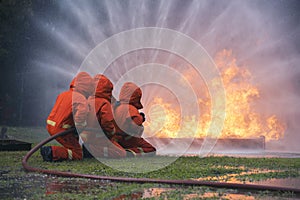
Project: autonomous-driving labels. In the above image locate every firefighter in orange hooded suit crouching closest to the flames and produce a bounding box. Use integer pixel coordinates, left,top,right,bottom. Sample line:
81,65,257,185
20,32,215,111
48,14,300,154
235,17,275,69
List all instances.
114,82,156,156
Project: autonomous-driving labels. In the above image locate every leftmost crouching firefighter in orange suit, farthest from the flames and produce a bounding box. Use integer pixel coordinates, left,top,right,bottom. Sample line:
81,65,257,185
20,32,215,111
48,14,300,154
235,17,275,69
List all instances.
41,72,94,161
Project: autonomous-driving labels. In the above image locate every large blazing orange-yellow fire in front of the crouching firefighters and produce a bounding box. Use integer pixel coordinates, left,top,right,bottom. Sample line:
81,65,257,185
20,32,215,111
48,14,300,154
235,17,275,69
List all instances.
145,50,285,141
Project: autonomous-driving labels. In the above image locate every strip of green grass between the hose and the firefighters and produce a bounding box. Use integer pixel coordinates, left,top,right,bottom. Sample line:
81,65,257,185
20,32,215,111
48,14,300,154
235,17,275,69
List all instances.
29,155,300,179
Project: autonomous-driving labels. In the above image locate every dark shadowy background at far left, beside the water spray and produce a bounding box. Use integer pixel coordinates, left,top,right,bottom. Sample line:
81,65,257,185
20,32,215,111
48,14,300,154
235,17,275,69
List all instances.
0,0,77,126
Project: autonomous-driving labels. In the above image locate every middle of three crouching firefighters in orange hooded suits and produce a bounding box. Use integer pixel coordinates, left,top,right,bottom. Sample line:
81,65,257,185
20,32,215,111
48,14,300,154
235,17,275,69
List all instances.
80,74,126,158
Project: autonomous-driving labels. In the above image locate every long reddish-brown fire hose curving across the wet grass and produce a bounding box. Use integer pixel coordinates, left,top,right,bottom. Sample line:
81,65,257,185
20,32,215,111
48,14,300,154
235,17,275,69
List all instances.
22,128,300,195
